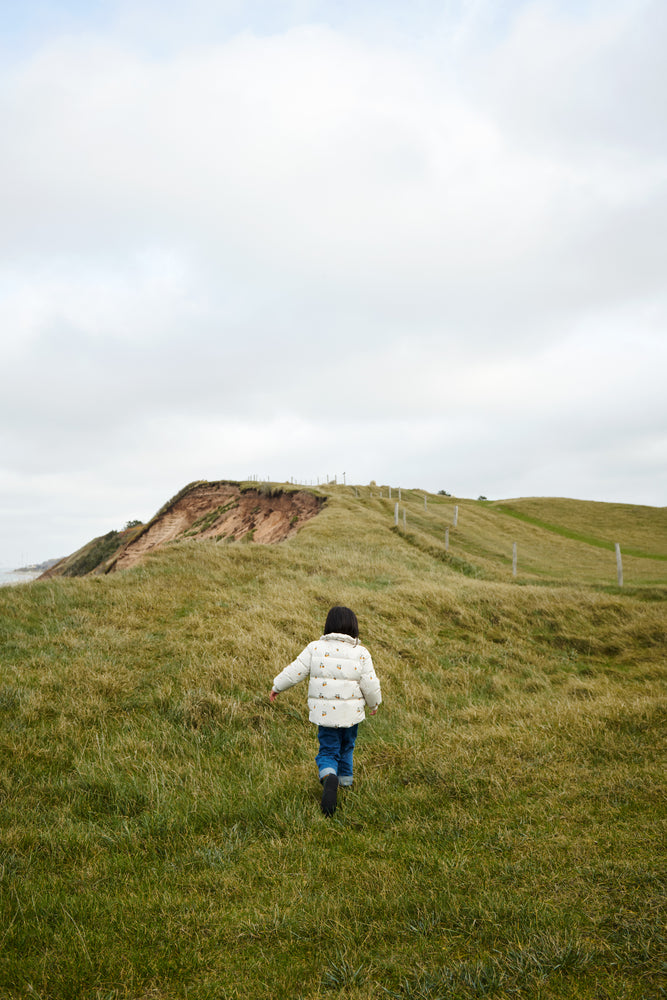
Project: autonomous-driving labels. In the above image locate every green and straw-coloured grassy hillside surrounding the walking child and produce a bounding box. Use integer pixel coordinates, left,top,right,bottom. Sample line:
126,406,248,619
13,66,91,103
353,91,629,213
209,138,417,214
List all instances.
0,487,667,1000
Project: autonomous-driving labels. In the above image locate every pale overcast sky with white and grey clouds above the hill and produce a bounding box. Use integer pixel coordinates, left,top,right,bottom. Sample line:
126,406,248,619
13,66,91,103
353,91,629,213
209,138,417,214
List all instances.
0,0,667,567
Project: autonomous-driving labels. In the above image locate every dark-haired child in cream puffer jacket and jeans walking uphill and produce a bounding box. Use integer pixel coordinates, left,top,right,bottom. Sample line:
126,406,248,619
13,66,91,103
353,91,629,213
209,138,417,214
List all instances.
269,606,382,816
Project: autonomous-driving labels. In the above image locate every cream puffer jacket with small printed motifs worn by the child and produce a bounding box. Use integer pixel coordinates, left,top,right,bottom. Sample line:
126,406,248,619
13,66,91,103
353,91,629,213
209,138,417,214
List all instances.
273,632,382,729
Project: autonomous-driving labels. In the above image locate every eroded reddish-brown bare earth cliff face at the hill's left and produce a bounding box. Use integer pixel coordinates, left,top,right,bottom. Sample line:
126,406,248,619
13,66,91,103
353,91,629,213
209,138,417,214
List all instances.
107,482,325,572
